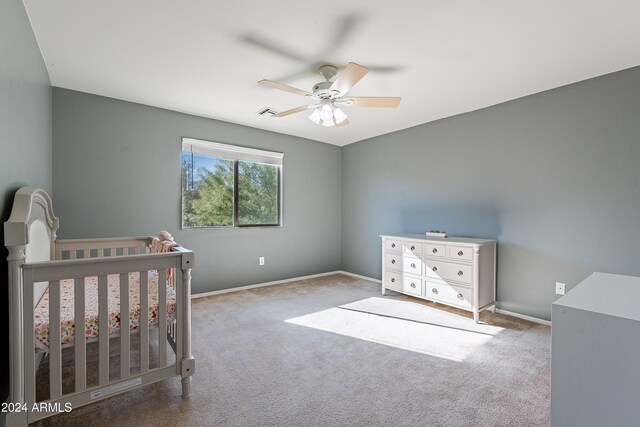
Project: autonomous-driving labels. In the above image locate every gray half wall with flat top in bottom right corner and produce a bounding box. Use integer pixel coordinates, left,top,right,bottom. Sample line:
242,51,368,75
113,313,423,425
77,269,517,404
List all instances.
550,274,640,427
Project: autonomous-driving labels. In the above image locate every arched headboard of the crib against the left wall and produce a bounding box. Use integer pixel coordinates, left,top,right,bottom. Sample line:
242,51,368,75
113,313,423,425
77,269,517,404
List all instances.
4,187,59,304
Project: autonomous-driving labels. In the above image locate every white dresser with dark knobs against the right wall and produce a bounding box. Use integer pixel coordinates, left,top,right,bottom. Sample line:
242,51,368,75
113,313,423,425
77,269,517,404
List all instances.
380,234,497,322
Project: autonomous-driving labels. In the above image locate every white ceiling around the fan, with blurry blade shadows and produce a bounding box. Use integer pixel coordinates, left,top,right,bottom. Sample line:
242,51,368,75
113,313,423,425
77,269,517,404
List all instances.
24,0,640,145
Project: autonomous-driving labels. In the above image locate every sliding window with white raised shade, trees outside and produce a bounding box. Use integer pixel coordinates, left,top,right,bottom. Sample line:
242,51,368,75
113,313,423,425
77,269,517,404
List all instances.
182,138,284,228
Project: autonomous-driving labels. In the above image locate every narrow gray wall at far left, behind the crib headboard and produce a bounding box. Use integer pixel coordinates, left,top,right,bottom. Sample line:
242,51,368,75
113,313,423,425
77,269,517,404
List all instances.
0,0,51,402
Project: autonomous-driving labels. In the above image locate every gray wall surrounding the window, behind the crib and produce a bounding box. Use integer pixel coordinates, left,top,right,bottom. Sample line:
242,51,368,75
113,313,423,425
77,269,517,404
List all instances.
53,88,341,293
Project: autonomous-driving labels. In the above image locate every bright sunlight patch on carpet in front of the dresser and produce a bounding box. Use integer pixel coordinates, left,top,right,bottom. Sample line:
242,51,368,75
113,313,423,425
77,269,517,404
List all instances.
286,297,503,362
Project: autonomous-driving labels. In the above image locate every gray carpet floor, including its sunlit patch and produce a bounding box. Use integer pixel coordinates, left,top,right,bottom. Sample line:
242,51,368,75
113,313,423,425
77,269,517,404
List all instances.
31,275,550,426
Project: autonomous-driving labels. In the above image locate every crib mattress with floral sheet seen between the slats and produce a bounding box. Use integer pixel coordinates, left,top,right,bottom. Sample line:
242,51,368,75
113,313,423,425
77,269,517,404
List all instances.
34,271,176,350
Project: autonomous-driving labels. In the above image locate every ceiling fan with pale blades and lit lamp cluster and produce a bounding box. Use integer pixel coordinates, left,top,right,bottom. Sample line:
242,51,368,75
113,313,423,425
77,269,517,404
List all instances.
258,62,401,127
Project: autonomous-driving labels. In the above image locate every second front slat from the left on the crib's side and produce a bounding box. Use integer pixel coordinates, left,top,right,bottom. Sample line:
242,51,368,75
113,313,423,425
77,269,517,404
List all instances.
49,280,62,400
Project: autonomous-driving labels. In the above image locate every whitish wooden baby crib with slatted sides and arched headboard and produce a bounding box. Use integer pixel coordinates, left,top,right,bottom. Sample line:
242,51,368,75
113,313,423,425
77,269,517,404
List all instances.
4,187,195,426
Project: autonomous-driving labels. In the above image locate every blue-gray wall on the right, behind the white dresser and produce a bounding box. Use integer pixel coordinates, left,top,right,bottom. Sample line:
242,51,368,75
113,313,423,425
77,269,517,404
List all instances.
342,67,640,319
